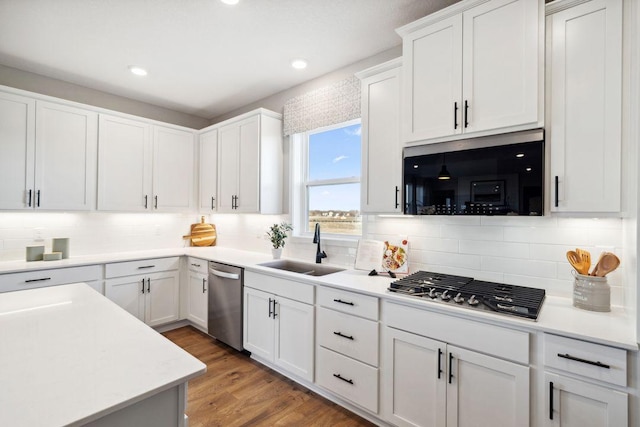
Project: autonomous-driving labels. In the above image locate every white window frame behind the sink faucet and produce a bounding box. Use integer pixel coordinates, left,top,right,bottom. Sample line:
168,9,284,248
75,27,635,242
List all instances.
289,119,362,243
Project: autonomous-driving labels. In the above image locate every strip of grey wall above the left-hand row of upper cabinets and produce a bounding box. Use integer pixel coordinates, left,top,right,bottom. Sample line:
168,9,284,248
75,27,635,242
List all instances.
0,65,209,129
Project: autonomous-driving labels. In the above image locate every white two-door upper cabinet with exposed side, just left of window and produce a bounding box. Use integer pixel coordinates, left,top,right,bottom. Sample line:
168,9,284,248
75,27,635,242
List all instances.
215,109,283,214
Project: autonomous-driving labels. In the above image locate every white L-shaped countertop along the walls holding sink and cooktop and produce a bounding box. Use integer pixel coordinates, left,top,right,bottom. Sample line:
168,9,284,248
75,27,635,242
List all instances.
0,246,638,351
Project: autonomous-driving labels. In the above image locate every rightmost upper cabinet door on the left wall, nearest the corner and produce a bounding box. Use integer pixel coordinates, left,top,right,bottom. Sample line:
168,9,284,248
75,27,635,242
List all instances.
153,126,195,212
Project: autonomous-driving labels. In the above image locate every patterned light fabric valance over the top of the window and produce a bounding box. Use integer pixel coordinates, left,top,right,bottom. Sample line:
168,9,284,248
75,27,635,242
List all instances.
283,76,360,136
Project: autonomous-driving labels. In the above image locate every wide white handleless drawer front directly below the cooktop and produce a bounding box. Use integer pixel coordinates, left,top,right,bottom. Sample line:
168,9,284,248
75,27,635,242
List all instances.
382,302,529,364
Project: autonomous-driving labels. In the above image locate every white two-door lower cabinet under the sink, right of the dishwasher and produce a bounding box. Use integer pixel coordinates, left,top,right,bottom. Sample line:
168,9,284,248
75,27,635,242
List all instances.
243,272,315,381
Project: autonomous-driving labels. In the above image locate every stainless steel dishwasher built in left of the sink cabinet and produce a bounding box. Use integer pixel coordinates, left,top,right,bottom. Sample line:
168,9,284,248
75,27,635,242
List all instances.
208,261,243,351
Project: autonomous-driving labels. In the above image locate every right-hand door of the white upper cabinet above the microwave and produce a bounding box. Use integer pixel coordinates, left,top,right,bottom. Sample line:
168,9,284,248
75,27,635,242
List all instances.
461,0,540,132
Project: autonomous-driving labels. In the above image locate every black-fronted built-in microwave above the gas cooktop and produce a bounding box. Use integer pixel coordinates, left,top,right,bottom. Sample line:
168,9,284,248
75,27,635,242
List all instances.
403,129,544,216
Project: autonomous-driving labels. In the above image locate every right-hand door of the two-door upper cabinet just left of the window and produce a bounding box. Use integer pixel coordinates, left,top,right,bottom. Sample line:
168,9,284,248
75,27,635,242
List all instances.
236,116,260,213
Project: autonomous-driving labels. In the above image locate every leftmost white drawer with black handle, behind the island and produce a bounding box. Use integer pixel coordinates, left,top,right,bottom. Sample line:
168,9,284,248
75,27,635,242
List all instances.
0,265,102,292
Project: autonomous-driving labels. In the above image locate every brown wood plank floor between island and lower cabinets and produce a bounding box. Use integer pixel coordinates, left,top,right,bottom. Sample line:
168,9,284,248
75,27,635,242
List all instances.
163,326,373,427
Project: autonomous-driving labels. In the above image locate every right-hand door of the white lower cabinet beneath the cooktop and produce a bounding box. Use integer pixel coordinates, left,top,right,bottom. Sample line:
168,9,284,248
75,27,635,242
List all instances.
447,346,529,427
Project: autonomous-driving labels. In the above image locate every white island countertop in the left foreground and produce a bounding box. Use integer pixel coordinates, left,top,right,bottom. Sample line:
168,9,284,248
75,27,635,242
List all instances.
0,284,206,427
